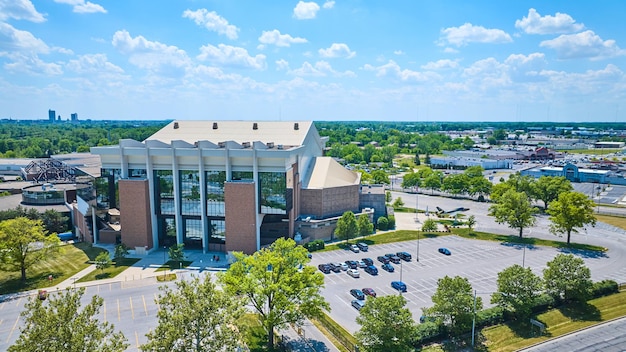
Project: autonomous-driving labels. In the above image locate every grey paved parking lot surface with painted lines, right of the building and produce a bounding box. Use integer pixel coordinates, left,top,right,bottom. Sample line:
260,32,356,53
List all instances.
312,236,605,333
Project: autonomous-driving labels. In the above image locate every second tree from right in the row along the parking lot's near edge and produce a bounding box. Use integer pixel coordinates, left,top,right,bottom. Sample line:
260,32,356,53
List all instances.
491,264,542,319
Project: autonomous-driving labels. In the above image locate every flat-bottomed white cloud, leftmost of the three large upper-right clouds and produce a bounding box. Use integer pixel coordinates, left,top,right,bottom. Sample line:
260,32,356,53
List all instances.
440,23,513,47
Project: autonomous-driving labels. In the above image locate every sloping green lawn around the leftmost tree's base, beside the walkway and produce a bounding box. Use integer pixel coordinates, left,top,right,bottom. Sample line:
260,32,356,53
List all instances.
0,243,105,294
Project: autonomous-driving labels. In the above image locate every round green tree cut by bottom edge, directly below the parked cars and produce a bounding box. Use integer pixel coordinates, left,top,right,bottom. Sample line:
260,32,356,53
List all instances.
355,295,415,352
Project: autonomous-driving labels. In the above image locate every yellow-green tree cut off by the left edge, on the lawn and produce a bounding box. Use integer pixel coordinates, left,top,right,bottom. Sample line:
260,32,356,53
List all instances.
0,217,61,282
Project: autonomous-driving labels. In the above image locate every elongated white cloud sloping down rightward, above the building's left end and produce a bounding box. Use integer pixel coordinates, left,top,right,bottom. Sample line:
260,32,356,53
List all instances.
112,30,190,70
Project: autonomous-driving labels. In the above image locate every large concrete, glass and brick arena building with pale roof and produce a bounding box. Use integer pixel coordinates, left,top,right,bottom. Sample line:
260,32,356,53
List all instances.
90,121,373,253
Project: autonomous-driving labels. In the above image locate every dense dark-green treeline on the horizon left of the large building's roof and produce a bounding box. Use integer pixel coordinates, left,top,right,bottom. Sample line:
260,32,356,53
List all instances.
0,120,167,158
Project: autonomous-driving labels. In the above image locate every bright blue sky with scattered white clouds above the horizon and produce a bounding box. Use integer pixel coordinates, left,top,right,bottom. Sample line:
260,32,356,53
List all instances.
0,0,626,122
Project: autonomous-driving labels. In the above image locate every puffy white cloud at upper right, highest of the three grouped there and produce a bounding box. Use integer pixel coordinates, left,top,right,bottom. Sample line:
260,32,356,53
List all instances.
515,8,585,34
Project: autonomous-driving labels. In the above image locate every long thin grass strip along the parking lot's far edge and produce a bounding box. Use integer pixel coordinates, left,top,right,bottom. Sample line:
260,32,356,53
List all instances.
321,228,606,252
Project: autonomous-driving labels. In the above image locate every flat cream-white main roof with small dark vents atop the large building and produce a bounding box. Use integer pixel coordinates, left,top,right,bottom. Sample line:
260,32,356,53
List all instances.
146,120,313,146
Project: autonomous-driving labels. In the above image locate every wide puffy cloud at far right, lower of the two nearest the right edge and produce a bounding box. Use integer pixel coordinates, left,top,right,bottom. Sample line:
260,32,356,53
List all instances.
539,30,626,60
